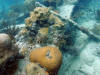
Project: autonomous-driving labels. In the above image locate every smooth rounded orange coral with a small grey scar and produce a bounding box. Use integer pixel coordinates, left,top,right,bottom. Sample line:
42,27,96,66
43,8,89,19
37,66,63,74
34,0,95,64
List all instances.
30,46,62,72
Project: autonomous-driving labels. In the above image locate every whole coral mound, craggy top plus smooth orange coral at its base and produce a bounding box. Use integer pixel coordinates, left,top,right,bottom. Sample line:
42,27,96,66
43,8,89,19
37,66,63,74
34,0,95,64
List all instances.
10,4,69,75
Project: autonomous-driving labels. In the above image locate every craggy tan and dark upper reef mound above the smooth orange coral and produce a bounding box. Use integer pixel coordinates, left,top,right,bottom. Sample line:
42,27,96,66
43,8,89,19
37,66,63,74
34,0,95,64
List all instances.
17,7,66,46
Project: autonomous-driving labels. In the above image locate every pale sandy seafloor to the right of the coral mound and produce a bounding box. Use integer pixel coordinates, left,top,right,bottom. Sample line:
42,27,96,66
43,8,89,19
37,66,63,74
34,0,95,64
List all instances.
0,0,100,75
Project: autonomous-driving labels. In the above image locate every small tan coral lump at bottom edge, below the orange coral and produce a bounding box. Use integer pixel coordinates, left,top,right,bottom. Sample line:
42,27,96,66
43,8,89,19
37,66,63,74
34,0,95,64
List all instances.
25,63,49,75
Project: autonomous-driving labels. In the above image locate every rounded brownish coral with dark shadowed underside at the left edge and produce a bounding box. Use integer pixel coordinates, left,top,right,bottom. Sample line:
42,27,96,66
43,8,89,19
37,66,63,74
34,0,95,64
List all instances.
0,33,20,75
